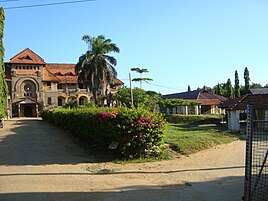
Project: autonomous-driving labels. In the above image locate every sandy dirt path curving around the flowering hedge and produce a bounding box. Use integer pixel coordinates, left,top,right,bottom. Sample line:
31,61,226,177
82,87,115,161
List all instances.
0,119,245,201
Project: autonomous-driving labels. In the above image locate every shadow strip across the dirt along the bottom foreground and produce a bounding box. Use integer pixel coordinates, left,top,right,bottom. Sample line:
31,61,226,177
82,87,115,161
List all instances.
0,177,244,201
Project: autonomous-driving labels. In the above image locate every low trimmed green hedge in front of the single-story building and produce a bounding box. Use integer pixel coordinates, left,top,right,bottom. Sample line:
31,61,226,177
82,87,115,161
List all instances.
165,114,222,123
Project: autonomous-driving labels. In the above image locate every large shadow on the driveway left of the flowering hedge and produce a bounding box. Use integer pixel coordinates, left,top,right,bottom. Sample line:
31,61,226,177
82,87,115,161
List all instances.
0,118,115,165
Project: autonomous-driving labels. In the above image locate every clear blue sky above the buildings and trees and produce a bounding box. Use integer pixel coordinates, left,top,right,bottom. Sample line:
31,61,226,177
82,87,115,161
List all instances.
0,0,268,94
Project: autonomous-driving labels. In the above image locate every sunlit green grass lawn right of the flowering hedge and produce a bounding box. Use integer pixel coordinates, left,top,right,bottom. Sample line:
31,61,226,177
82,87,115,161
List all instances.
165,124,241,154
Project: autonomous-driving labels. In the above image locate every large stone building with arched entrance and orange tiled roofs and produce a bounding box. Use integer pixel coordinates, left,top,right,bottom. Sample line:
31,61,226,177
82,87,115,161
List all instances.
5,48,123,117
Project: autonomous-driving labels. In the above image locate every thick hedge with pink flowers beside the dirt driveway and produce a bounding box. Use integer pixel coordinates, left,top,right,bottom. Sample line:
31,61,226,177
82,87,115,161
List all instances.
42,107,164,158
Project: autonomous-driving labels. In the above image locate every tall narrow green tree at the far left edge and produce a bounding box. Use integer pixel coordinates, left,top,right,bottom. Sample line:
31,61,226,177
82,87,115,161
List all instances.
0,7,8,118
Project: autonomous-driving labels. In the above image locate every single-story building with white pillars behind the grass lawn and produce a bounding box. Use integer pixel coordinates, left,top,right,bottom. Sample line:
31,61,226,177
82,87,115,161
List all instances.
162,89,227,115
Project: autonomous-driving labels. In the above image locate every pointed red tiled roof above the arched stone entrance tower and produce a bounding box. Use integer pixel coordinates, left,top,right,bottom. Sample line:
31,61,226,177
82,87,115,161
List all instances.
8,48,45,64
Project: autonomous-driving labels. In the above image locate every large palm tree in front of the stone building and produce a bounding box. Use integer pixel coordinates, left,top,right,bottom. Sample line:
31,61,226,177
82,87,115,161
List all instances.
75,35,120,104
